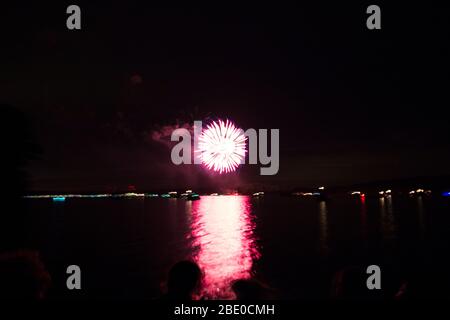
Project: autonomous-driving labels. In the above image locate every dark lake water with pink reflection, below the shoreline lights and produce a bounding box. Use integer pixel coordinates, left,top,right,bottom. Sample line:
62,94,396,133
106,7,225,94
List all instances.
27,195,450,299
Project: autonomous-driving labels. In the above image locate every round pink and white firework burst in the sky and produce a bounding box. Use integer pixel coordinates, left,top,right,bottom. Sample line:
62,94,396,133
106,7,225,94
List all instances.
197,120,246,173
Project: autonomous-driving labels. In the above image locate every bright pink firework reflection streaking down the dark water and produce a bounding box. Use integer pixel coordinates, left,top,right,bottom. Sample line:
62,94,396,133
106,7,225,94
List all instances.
190,196,260,299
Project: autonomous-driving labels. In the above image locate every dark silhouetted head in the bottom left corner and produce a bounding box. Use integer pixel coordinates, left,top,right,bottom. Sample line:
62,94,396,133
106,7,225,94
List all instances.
0,251,50,300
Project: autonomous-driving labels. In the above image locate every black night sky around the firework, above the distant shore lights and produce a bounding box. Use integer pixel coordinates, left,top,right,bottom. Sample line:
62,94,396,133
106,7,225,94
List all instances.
0,1,450,191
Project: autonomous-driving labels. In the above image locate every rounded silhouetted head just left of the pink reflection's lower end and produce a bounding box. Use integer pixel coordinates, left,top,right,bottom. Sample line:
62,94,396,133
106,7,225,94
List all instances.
163,261,202,301
